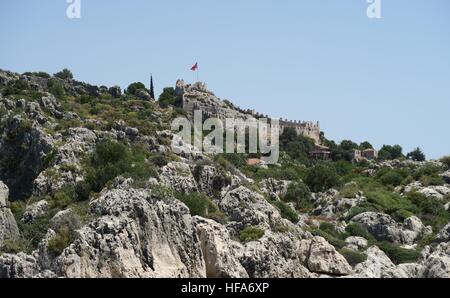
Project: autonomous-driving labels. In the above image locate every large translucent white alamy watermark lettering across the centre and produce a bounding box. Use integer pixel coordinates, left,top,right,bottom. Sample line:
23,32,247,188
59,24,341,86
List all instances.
171,110,280,164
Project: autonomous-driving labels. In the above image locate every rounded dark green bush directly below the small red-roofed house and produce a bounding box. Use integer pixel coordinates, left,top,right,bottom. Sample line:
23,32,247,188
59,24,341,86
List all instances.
304,163,340,192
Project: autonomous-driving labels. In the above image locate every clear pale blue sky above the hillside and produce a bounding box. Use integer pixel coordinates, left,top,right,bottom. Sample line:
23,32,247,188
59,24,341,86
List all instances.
0,0,450,158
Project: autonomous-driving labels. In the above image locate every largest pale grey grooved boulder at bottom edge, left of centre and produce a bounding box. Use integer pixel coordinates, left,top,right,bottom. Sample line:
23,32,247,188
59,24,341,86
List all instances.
53,189,206,277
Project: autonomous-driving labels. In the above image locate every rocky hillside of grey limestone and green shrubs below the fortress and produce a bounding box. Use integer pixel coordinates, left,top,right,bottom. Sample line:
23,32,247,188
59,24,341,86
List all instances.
0,71,450,278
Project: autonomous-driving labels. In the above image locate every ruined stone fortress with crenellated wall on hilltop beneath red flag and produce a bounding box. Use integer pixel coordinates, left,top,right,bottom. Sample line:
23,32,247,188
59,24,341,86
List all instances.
175,80,321,145
